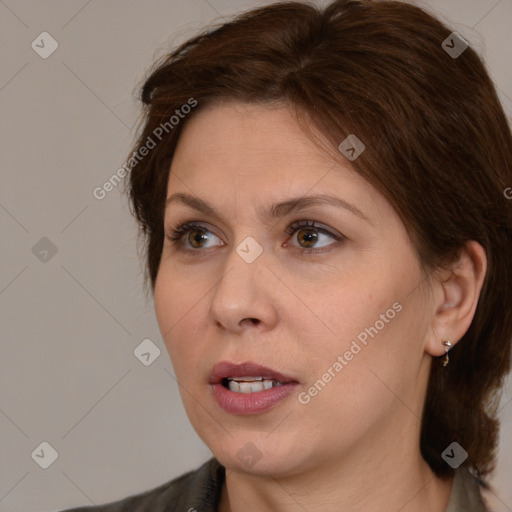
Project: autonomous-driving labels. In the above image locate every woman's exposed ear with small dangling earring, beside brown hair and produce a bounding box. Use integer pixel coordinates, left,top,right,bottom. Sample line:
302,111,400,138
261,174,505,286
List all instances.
425,240,487,356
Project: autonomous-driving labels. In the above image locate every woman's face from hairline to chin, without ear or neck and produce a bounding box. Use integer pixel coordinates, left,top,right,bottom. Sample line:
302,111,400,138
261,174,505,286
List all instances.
154,103,440,475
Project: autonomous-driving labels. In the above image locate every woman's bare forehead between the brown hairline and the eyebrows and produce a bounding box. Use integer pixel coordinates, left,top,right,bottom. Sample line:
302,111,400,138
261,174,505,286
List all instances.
167,102,385,225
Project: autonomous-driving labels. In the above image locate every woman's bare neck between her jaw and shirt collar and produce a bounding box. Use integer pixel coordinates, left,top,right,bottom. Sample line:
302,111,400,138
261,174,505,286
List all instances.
219,426,453,512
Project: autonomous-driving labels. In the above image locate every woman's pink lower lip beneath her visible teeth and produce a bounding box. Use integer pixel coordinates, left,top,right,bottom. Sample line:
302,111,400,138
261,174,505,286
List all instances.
212,382,298,414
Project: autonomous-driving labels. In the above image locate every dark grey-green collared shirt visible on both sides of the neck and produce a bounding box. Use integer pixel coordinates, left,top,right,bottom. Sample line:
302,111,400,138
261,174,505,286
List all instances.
61,458,487,512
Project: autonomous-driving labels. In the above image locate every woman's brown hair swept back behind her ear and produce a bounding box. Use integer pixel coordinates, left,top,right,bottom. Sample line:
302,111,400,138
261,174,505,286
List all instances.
124,0,512,488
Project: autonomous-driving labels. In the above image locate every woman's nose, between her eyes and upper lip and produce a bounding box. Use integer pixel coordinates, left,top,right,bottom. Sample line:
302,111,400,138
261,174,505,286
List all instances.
209,242,278,334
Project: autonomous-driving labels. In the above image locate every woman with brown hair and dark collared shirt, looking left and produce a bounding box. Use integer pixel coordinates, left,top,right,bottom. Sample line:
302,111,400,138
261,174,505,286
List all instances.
61,0,512,512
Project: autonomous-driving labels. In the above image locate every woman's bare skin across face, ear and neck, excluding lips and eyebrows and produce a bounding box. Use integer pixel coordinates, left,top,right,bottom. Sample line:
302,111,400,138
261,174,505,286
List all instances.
154,102,486,512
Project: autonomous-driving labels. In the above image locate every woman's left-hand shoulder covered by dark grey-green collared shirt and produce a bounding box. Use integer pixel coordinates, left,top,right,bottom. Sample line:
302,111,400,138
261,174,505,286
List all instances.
57,458,225,512
